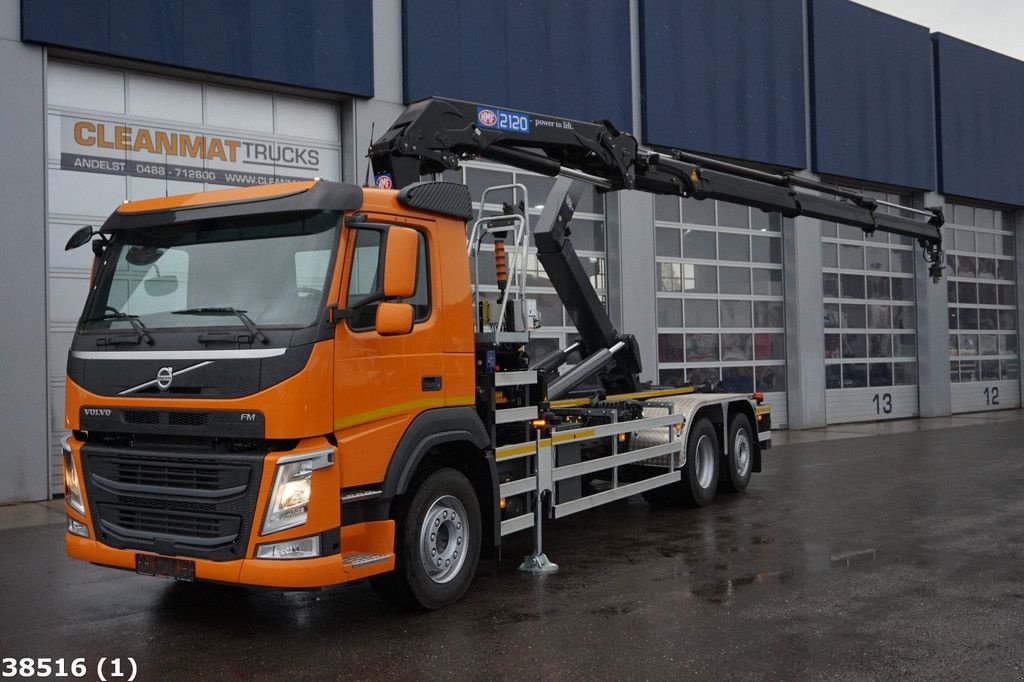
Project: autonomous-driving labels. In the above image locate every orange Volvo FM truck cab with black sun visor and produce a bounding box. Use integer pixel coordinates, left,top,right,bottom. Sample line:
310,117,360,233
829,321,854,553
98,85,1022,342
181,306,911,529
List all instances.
65,176,495,602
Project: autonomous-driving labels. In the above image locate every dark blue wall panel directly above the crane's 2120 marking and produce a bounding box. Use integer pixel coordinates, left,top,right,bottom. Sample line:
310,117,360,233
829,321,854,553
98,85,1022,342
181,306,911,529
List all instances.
402,0,633,130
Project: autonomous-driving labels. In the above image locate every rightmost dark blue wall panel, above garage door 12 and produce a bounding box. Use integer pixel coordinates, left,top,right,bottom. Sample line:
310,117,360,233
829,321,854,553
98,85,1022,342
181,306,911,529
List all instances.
932,34,1024,206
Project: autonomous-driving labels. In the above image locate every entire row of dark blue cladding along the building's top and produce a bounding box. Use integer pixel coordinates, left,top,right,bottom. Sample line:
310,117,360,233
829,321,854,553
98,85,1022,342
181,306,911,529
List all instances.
22,0,1024,205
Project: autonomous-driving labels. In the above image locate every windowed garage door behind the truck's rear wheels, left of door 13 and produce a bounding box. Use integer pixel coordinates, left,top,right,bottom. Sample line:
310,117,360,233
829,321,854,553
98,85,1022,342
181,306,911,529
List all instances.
654,196,788,427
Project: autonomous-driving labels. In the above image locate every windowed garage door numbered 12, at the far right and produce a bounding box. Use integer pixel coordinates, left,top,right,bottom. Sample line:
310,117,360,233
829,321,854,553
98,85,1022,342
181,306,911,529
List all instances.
944,204,1021,413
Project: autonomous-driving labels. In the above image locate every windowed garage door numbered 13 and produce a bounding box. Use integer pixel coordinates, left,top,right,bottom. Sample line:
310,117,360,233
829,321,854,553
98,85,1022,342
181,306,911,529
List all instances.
821,193,919,424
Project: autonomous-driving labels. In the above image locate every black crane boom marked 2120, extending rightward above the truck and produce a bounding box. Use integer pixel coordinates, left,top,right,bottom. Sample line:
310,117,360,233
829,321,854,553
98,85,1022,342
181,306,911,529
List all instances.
370,97,944,264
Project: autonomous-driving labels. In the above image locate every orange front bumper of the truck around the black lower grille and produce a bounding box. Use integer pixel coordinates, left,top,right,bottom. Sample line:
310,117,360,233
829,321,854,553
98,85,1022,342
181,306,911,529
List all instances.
65,438,394,589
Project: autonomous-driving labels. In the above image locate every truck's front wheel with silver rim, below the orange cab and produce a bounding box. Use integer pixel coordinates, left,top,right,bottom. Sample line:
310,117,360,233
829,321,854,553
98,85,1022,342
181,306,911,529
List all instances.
370,468,482,610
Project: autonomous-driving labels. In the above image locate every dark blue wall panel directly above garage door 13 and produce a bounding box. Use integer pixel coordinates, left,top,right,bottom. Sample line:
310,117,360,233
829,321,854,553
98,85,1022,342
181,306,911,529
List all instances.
809,0,936,189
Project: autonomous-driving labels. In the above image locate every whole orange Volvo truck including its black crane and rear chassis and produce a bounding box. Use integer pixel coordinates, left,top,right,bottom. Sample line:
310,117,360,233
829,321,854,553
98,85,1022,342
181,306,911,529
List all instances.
63,98,942,608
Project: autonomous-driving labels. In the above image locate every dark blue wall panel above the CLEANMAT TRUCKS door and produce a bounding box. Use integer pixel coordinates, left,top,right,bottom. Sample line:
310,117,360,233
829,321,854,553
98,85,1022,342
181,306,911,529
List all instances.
22,0,374,97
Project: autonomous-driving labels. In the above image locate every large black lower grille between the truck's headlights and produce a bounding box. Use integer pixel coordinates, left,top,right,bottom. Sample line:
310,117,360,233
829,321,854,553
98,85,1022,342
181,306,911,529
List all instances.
82,442,265,561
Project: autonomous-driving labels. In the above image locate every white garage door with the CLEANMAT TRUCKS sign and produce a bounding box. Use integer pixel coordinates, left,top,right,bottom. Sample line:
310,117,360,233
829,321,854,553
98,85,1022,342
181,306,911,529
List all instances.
47,61,341,494
